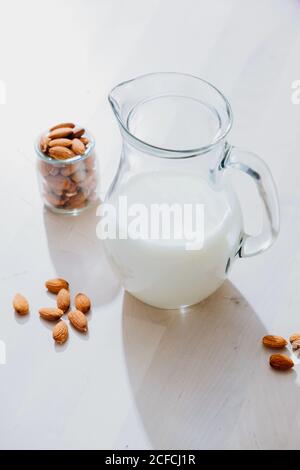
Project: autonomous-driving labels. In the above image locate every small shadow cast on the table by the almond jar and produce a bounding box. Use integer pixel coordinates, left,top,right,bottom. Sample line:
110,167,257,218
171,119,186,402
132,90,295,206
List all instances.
44,207,120,306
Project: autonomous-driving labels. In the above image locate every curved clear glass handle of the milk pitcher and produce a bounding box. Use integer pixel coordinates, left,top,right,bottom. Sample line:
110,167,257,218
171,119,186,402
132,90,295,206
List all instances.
223,146,279,258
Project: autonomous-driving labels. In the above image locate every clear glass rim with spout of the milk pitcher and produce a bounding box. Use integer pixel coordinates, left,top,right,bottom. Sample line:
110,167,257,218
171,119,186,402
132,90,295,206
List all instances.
108,72,233,159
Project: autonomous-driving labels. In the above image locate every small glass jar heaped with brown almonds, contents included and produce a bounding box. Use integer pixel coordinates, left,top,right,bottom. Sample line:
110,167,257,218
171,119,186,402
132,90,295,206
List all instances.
35,123,98,215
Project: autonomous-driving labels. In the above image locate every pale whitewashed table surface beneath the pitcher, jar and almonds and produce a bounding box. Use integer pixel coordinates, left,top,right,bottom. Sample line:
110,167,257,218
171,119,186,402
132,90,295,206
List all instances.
0,0,300,449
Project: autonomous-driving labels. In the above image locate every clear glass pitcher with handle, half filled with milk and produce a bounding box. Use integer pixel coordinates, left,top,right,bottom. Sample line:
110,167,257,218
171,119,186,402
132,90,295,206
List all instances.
102,73,279,309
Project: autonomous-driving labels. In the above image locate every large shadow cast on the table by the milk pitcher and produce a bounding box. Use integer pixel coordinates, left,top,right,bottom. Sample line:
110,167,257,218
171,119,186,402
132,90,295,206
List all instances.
122,281,298,449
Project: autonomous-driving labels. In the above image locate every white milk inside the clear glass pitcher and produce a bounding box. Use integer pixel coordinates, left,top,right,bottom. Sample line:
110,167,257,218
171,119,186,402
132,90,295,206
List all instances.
105,172,242,308
